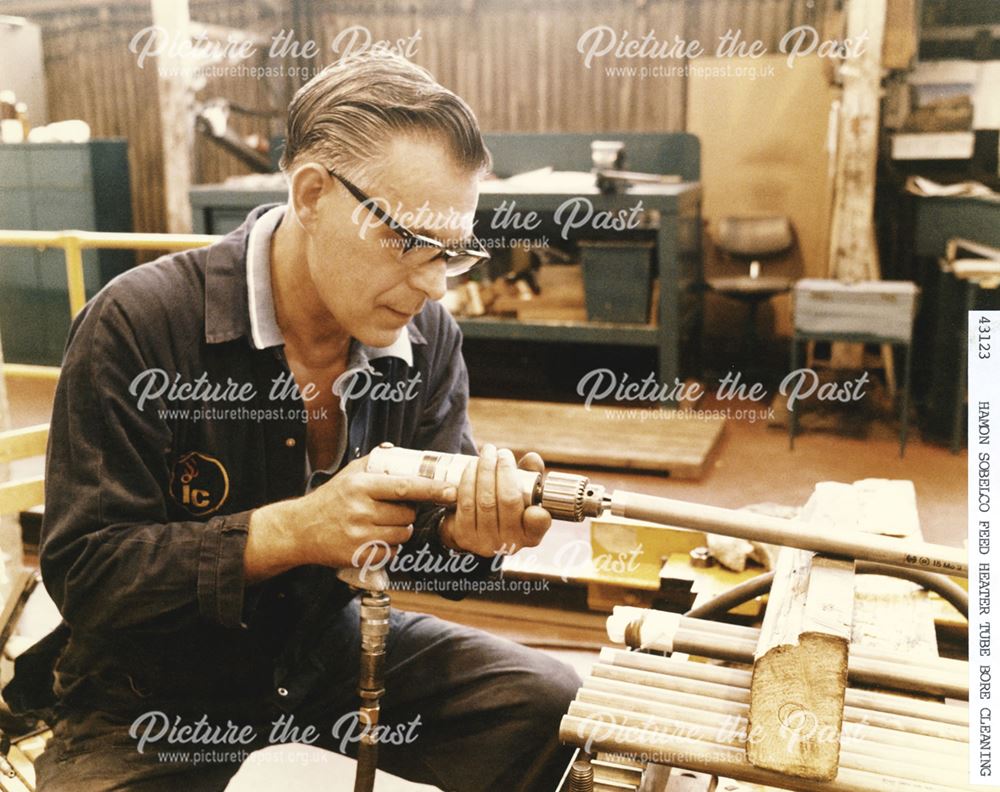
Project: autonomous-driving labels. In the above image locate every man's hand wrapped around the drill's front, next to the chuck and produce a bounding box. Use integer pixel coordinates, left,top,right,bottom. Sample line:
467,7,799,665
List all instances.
441,444,552,558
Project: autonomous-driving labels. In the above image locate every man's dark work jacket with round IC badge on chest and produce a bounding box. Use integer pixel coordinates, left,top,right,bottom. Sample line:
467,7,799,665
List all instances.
31,207,489,717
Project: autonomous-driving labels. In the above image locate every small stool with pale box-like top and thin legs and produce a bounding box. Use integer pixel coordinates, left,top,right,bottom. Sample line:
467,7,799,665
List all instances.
788,278,919,457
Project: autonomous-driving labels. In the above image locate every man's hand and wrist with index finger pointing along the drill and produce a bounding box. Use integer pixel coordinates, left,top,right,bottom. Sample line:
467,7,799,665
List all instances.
244,457,457,583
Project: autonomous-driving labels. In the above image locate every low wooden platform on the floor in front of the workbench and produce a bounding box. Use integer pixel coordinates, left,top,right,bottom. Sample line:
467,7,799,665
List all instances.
469,399,725,479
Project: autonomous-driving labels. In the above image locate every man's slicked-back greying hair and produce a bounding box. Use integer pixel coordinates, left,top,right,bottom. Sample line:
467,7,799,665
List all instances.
280,54,490,184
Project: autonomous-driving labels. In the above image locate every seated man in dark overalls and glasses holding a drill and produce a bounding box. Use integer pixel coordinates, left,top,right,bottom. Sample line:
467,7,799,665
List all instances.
12,56,579,792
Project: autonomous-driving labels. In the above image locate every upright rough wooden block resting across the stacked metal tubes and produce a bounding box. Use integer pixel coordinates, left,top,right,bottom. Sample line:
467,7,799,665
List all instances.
746,548,854,781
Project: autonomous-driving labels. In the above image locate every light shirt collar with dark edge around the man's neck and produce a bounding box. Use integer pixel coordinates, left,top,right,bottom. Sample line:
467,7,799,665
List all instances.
219,204,418,368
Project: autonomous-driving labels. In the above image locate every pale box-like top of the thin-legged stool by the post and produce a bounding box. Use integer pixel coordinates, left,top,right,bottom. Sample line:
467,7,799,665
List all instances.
793,278,920,342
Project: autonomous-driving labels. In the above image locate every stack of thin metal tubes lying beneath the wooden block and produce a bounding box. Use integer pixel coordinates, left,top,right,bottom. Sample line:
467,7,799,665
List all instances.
560,648,972,792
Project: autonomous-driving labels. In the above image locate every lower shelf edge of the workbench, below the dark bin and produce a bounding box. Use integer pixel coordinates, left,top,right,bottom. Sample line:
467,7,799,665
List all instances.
458,318,660,347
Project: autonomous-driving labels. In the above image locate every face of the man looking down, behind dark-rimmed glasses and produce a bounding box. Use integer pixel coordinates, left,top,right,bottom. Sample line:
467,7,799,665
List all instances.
307,137,479,347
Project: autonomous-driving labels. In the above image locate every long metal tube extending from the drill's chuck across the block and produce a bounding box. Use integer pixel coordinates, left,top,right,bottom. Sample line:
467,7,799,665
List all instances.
610,490,969,577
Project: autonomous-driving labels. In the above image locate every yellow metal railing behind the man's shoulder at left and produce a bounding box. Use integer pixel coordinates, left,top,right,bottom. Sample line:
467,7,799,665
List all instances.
0,230,221,379
